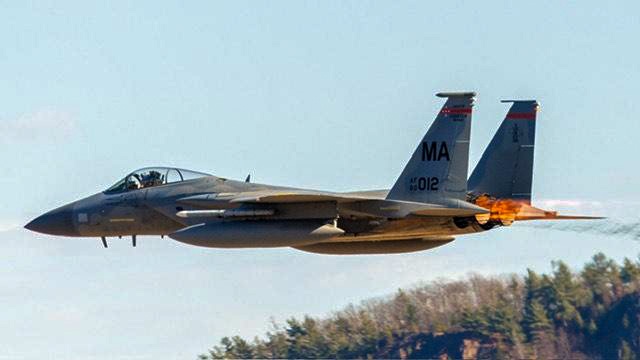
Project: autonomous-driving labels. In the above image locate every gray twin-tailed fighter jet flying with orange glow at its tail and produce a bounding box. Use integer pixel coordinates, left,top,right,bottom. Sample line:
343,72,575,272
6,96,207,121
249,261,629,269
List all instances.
25,92,596,254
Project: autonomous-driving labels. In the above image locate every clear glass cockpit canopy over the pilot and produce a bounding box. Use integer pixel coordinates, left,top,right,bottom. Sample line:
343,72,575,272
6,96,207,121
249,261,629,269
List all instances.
105,167,211,194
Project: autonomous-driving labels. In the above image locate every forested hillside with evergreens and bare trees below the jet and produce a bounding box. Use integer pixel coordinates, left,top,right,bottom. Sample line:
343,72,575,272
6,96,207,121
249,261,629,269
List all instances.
200,254,640,359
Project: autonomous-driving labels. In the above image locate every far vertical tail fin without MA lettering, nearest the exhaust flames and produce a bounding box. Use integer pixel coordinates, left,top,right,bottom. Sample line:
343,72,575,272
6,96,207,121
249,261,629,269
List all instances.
469,100,538,203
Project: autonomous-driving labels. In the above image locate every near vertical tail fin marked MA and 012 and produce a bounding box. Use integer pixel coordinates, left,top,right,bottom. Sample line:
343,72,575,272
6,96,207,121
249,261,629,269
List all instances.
387,92,475,204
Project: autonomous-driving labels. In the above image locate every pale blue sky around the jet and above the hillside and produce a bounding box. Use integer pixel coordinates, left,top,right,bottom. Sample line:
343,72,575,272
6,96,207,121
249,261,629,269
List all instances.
0,1,640,359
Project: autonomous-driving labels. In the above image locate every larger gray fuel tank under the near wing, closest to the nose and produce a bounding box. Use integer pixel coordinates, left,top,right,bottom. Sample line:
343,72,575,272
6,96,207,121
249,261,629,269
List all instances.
169,220,344,248
